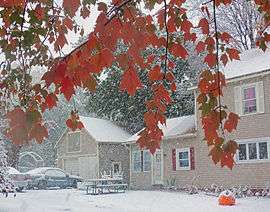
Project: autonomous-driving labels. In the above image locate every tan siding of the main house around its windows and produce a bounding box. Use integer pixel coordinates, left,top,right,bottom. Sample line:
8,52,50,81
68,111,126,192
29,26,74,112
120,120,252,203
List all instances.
130,72,270,189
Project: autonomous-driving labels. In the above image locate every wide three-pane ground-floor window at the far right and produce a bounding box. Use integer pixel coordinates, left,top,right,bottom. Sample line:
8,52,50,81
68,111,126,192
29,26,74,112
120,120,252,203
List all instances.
237,139,270,162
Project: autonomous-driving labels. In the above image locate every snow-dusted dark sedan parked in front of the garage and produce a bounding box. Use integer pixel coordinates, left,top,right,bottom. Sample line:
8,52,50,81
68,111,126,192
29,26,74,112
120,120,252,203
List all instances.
27,167,83,189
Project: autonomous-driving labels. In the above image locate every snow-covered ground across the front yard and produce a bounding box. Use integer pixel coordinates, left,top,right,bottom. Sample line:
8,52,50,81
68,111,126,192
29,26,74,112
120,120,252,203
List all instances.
0,190,270,212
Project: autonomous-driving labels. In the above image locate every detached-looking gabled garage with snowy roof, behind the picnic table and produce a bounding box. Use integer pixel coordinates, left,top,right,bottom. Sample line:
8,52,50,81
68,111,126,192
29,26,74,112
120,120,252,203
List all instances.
56,116,130,182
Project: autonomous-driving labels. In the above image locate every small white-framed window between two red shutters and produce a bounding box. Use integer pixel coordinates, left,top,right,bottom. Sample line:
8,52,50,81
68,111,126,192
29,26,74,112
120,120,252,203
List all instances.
176,148,190,170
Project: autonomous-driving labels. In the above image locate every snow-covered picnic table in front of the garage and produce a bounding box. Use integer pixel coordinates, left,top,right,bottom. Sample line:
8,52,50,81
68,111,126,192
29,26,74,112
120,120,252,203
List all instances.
85,178,128,195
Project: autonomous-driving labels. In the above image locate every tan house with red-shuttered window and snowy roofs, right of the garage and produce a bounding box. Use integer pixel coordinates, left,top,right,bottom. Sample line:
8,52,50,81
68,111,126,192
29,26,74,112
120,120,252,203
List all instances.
127,49,270,189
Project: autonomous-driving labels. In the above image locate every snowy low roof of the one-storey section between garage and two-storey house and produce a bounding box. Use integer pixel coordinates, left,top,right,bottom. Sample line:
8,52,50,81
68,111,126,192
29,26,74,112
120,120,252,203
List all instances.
127,115,196,142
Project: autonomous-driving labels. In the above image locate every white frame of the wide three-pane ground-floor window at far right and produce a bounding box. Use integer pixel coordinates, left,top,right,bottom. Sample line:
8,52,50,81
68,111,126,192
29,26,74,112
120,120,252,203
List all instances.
235,137,270,164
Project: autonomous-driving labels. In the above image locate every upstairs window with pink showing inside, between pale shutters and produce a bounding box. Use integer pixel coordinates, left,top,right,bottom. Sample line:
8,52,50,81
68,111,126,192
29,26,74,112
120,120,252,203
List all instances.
242,86,257,114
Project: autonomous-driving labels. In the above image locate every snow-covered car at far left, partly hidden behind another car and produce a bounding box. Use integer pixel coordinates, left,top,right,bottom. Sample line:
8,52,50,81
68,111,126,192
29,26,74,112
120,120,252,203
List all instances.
7,167,30,191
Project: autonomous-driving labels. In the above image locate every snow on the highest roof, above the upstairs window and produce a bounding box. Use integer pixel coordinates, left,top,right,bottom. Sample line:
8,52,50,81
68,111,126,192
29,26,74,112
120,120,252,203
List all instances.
223,48,270,79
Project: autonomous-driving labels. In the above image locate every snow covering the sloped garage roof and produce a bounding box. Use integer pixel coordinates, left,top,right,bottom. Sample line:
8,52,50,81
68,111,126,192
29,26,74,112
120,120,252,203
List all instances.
80,116,131,143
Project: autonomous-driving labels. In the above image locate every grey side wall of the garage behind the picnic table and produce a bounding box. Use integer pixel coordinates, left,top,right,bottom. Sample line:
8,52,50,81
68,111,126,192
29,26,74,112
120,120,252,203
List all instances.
98,143,129,183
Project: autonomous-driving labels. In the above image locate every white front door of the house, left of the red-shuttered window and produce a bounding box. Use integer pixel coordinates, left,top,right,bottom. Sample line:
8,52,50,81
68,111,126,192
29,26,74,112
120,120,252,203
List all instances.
152,150,163,185
